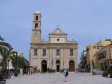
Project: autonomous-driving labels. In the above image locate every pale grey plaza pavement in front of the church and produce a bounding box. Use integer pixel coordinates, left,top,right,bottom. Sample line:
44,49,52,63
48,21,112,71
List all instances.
6,72,112,84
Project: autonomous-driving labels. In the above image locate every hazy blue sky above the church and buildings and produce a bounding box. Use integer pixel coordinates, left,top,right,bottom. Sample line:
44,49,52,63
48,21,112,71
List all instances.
0,0,112,61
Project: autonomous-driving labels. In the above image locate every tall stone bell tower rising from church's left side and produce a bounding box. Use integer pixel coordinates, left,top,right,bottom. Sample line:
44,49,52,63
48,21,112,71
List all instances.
31,11,41,43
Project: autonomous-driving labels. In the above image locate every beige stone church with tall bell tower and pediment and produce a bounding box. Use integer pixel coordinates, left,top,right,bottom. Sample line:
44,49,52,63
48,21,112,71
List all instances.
29,11,78,72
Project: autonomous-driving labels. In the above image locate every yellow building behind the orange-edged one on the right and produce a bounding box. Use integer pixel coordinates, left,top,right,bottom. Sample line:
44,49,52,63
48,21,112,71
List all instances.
86,40,111,72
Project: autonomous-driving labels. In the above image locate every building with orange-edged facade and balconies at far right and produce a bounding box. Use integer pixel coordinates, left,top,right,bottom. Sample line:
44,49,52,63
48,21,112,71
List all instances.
97,44,112,70
